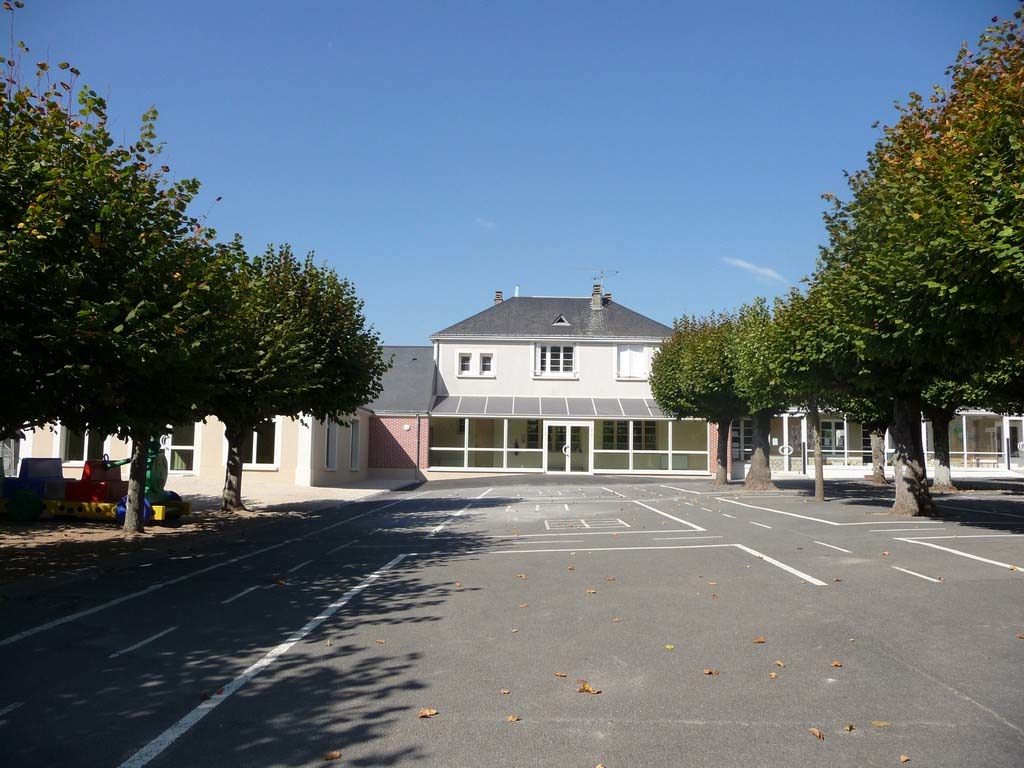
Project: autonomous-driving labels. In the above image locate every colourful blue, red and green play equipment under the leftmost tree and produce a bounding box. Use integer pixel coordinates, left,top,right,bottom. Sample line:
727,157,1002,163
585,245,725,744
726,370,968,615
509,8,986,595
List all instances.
0,440,191,523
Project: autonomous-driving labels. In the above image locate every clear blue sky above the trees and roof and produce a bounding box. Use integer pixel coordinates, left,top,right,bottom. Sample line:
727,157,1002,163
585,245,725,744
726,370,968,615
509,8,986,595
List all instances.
15,0,1016,344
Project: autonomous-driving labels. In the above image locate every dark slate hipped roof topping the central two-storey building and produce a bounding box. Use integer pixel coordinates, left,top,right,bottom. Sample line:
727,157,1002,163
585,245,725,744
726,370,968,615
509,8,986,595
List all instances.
430,296,672,340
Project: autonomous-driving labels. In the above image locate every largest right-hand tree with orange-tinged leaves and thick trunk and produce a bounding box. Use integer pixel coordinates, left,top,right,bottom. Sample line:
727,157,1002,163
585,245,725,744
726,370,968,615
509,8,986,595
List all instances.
815,9,1024,514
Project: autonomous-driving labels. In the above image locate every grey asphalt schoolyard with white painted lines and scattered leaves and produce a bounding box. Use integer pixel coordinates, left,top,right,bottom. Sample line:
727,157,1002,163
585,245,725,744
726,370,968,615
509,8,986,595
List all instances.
0,476,1024,768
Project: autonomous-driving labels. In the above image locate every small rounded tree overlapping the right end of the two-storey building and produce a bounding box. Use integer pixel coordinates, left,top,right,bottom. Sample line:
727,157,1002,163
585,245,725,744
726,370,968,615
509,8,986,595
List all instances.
650,312,746,484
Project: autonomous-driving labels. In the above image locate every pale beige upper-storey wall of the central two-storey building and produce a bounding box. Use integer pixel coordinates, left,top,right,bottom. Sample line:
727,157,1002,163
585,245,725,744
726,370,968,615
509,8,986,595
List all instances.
437,340,652,397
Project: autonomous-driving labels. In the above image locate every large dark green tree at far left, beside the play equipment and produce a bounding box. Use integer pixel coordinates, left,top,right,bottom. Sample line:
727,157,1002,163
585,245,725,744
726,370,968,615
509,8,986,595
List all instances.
0,20,232,532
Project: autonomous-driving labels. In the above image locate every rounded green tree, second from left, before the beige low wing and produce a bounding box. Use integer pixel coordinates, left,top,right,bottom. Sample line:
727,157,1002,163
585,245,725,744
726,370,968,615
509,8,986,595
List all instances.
203,246,387,510
